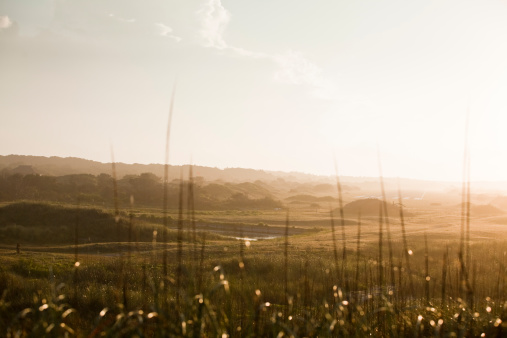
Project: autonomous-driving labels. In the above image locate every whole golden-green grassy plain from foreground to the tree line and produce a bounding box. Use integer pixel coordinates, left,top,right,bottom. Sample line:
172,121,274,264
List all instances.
0,195,507,336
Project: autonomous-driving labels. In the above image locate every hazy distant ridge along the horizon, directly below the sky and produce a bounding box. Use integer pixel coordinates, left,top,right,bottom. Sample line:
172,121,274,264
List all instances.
0,155,507,197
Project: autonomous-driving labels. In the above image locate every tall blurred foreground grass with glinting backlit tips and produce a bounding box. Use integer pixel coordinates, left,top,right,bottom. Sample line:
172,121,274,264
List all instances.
1,198,505,336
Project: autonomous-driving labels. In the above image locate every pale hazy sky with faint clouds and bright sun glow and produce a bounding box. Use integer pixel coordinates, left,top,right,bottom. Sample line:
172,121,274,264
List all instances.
0,0,507,181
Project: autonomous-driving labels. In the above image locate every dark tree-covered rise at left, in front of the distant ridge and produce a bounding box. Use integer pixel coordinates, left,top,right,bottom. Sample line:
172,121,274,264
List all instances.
0,173,282,209
